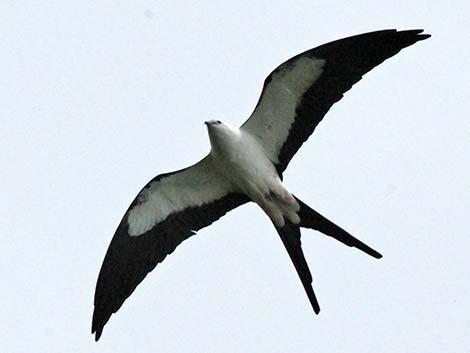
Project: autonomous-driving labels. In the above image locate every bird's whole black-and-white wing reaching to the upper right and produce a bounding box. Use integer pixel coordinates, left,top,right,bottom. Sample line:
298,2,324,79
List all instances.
242,30,430,174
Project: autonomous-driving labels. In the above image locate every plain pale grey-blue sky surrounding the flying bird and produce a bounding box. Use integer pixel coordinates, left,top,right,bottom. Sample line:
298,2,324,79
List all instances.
0,0,470,353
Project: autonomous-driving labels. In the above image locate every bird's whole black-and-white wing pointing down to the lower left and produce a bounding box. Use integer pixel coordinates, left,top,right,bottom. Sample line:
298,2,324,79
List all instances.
92,156,249,340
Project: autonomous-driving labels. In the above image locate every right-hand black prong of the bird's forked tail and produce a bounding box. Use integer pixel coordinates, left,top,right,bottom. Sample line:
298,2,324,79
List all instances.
295,198,382,259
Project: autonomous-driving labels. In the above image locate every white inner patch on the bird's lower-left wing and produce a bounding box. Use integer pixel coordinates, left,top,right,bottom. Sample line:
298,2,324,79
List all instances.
127,157,231,236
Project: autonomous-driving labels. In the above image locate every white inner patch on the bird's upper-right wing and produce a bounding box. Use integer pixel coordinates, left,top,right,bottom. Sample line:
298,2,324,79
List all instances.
242,56,325,163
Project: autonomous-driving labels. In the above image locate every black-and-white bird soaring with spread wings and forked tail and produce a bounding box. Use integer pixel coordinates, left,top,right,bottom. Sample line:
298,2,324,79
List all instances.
92,30,430,340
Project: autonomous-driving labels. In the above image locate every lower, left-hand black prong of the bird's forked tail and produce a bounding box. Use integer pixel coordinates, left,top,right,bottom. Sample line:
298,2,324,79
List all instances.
276,220,320,314
